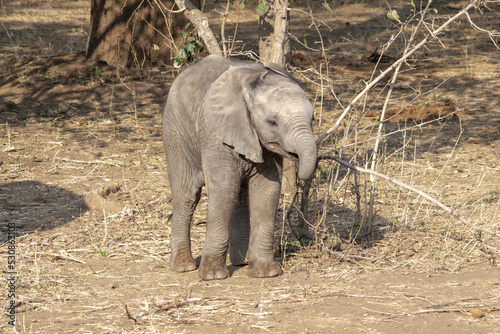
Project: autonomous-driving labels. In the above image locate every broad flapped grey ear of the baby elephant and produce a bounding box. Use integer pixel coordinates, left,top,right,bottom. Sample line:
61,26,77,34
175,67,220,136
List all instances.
202,64,267,163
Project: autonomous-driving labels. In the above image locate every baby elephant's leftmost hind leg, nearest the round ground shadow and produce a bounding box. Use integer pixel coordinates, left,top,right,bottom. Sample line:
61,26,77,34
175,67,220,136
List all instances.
170,172,202,272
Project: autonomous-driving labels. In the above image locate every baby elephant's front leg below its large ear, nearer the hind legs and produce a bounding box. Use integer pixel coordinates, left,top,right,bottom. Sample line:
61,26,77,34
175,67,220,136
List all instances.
198,167,241,280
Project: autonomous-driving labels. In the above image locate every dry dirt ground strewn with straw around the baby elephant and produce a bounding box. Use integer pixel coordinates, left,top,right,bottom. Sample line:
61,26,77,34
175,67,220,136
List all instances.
0,0,500,334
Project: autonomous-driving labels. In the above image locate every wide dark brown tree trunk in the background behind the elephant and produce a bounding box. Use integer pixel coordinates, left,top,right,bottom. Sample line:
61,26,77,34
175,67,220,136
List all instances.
86,0,200,67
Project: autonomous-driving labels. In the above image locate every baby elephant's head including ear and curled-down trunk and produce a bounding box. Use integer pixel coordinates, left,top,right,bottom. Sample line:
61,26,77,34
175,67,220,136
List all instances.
203,63,316,180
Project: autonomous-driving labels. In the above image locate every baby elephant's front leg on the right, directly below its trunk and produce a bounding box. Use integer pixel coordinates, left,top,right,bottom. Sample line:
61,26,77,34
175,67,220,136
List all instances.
247,159,283,277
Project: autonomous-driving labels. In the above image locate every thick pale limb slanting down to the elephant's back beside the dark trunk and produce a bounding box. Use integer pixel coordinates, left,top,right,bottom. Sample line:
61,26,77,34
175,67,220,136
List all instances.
175,0,222,56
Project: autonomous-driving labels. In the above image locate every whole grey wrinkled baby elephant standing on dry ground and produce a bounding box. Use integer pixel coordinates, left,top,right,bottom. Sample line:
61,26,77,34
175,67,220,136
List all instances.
163,55,316,280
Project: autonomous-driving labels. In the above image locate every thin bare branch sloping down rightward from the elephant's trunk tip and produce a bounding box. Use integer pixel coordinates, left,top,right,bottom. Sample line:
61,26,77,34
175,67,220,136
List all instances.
318,155,497,236
